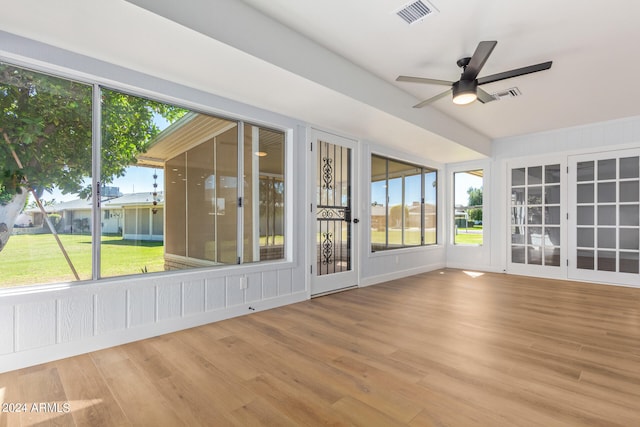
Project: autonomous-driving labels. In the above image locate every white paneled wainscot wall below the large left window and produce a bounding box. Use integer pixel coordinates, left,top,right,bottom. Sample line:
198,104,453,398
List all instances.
0,263,308,372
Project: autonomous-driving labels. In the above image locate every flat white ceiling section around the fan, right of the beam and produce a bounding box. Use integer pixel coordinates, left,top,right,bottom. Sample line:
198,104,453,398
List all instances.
243,0,640,138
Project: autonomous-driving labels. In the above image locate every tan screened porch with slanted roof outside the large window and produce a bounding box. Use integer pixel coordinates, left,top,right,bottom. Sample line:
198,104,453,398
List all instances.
140,112,285,269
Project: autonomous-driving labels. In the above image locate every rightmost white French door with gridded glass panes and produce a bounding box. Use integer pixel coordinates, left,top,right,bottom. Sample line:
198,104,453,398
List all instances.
569,149,640,286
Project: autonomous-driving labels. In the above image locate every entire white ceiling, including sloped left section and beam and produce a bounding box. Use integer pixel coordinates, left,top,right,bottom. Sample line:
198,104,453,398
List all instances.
0,0,640,163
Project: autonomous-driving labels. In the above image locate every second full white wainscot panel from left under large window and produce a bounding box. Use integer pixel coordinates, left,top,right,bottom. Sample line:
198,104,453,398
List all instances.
58,293,94,342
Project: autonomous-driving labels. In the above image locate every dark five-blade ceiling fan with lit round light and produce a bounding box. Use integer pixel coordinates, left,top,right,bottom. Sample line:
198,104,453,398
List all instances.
396,41,552,108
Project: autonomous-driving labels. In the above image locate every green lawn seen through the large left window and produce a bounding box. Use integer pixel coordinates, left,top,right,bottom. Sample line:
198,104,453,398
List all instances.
0,234,164,287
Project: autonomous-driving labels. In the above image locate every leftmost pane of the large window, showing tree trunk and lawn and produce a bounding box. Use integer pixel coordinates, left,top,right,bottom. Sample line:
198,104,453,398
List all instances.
0,63,93,287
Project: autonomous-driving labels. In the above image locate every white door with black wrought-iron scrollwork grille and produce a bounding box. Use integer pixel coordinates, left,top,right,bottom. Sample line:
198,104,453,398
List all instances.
311,130,359,296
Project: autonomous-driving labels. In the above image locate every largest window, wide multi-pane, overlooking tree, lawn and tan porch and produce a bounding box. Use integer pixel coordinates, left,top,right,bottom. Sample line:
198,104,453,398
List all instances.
0,64,285,287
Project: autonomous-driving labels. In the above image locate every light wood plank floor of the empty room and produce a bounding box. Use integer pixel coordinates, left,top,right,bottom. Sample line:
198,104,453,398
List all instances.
0,270,640,427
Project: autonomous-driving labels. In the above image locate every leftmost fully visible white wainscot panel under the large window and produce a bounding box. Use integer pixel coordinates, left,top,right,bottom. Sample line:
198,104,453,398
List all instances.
16,300,56,351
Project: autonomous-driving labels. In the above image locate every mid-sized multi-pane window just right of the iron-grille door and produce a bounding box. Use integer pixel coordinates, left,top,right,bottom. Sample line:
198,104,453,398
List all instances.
371,155,437,252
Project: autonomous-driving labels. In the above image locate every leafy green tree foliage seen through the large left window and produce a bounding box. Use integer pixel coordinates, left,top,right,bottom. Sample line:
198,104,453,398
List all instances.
0,63,186,251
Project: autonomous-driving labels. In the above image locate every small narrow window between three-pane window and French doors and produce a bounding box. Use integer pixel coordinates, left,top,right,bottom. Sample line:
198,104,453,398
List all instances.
453,169,484,245
